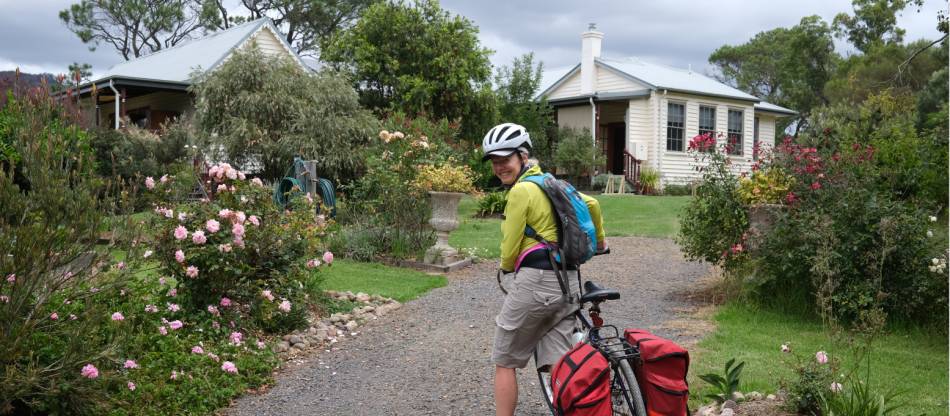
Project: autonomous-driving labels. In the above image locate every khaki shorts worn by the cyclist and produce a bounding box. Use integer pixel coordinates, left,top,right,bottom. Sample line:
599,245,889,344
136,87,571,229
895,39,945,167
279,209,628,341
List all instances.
492,267,577,368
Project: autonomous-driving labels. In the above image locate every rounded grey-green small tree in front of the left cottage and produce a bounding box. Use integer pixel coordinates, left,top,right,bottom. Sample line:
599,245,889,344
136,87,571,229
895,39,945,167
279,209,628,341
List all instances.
191,45,378,181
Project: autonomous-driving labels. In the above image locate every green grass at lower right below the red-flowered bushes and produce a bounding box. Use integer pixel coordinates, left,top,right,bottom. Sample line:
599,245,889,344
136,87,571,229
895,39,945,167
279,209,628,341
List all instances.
690,304,948,415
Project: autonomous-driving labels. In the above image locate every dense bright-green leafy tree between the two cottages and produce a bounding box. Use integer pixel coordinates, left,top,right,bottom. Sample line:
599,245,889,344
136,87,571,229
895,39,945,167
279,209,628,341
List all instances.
322,0,494,140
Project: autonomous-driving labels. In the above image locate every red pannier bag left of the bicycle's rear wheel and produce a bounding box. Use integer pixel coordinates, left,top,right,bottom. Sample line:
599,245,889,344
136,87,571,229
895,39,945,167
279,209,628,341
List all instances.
551,342,613,416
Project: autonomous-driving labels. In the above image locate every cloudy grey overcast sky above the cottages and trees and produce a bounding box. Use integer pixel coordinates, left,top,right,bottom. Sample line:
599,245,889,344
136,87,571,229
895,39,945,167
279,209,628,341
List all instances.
0,0,947,79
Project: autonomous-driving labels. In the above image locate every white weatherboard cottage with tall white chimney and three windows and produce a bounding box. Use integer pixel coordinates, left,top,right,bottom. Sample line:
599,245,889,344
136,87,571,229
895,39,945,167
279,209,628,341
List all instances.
537,25,797,186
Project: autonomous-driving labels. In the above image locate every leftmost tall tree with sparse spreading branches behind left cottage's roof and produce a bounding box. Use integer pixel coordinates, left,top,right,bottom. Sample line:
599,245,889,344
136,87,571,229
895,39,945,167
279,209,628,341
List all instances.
59,0,214,60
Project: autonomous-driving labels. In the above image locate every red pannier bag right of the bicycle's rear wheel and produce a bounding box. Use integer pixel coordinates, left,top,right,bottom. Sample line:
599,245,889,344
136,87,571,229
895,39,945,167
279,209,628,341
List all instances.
623,329,689,416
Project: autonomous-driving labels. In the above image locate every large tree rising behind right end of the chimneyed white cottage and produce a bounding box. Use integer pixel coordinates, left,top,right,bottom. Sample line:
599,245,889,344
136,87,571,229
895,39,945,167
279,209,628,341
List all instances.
709,16,840,135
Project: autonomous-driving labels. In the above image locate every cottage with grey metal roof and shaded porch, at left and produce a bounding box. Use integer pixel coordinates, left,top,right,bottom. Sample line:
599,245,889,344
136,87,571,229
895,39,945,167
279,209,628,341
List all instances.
79,17,310,130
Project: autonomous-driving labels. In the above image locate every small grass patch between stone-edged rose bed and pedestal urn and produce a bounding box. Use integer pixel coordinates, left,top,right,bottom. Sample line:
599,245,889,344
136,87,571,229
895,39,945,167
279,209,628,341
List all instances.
320,259,448,302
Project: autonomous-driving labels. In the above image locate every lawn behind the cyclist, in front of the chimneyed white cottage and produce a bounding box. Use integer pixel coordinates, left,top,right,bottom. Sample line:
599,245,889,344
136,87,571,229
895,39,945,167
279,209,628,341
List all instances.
449,195,690,258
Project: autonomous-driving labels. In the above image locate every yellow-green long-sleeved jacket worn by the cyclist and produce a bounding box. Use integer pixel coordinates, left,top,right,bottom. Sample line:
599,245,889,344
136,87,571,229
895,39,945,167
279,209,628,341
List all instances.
501,165,604,271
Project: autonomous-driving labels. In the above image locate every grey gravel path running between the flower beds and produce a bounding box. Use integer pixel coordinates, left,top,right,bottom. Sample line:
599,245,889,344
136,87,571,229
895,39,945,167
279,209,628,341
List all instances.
225,237,709,416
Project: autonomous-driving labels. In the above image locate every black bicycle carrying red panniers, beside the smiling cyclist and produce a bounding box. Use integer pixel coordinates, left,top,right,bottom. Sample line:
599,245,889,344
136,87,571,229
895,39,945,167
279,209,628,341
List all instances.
535,249,646,416
